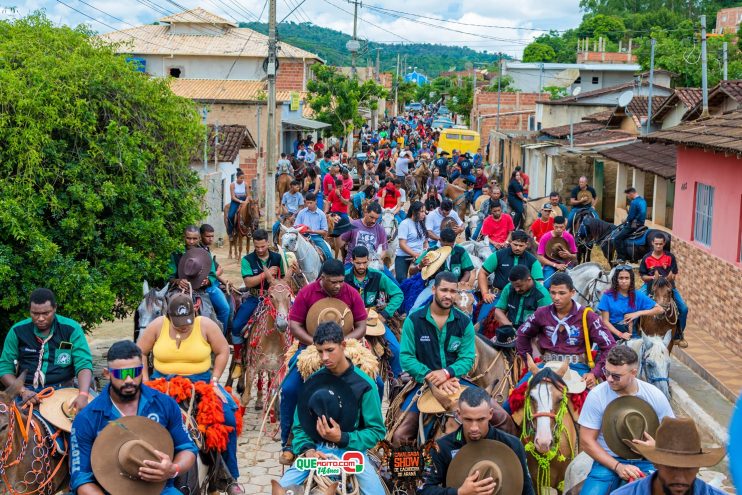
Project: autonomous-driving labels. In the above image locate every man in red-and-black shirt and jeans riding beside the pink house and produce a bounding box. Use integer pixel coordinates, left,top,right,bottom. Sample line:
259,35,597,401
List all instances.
639,235,688,348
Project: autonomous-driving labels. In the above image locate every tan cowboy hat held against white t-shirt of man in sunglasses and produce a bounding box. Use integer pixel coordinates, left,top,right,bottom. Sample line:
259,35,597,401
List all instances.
601,395,660,459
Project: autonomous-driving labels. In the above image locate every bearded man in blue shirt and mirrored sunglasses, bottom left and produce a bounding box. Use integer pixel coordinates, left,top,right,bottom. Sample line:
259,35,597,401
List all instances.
70,340,198,495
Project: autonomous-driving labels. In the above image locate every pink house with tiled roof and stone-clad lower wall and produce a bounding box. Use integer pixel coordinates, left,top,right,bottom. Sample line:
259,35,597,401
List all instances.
642,110,742,349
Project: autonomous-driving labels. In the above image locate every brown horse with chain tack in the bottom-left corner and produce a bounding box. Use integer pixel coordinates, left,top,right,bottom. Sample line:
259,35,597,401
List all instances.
0,372,70,495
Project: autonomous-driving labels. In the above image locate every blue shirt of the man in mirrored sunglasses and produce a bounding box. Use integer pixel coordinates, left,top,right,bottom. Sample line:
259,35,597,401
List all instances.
70,385,198,492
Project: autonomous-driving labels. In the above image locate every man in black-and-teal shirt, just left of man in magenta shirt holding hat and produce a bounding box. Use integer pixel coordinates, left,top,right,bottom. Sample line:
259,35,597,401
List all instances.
477,230,544,322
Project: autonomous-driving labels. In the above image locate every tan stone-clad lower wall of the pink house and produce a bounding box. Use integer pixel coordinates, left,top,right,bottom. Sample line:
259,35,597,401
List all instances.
672,236,742,348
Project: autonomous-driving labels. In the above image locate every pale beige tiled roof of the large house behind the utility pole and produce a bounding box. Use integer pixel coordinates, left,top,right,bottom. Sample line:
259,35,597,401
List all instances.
99,25,321,60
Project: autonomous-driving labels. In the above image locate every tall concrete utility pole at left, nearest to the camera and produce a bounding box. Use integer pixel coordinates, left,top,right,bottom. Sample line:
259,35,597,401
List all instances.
265,0,278,230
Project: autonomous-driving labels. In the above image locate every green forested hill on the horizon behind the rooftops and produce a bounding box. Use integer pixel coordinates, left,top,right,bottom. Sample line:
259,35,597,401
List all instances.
240,22,507,79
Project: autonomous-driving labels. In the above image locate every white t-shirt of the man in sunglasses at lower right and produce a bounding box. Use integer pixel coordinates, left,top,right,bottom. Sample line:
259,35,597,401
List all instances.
578,380,675,457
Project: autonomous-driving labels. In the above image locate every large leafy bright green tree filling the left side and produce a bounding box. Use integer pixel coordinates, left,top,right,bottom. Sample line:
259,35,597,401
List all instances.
0,13,204,336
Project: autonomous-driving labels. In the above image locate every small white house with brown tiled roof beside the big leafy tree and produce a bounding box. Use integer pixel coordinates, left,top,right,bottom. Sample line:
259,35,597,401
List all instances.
191,125,257,236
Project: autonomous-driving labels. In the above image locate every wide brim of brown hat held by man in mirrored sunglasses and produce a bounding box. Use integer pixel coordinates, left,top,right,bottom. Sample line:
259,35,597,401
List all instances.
90,416,175,495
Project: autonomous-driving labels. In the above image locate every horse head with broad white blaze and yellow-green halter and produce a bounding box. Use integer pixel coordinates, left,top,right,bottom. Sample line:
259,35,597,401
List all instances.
525,354,569,454
